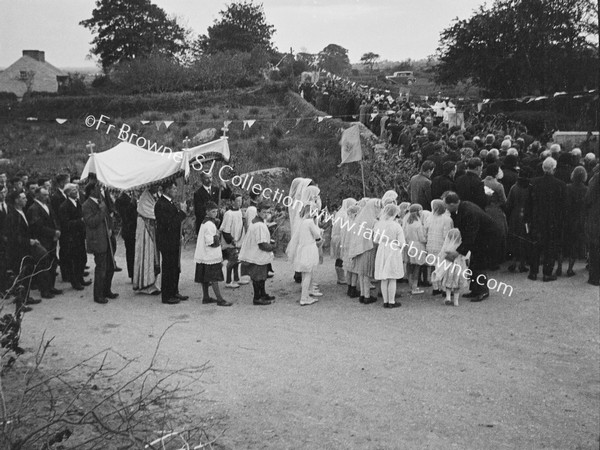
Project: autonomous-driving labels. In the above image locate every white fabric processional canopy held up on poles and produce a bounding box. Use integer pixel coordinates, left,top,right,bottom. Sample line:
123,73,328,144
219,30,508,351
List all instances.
81,138,230,190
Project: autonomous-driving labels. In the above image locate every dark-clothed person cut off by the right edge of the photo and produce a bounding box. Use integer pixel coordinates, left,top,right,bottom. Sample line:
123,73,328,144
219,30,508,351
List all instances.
584,166,600,286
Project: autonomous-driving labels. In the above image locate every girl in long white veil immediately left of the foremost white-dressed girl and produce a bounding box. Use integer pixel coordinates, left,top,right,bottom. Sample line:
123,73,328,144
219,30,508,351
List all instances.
348,198,381,304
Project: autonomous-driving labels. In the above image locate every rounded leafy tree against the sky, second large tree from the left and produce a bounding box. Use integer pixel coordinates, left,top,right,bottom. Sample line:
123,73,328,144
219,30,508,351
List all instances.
197,1,275,54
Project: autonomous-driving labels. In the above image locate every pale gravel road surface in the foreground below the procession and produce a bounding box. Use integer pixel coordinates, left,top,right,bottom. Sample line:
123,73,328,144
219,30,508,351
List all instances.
23,246,600,449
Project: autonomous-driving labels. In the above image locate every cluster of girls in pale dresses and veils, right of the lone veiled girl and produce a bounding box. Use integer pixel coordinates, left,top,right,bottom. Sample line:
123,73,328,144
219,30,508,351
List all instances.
331,191,468,308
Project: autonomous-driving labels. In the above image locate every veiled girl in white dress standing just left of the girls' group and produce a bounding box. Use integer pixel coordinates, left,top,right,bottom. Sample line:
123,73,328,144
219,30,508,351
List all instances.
287,203,322,306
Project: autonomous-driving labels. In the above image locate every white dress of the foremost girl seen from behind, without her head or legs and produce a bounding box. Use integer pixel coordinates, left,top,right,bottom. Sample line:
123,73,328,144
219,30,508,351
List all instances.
374,220,405,280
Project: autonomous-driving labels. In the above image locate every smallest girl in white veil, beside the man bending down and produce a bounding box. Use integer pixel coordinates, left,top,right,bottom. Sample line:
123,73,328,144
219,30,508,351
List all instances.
432,228,470,306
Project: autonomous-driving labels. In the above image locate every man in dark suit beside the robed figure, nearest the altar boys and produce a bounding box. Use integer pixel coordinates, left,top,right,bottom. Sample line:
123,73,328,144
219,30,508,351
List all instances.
154,181,189,305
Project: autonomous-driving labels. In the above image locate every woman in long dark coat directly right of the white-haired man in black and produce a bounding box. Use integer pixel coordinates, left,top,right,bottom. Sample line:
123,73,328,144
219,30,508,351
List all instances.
563,166,588,277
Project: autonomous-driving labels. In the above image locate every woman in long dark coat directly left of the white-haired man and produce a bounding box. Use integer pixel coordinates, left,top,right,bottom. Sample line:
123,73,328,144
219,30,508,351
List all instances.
506,166,532,272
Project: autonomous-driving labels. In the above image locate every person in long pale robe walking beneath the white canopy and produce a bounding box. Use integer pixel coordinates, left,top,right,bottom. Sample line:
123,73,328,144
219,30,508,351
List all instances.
133,186,160,295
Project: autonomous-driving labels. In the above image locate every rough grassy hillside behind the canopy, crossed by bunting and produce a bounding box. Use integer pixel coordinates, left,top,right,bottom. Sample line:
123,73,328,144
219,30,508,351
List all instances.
0,85,418,205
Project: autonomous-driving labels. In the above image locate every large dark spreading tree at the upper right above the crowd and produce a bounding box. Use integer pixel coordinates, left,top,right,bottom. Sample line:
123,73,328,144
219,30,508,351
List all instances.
435,0,598,97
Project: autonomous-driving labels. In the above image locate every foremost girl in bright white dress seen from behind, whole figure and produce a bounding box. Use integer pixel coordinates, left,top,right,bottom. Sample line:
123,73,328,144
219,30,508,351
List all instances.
374,204,405,308
